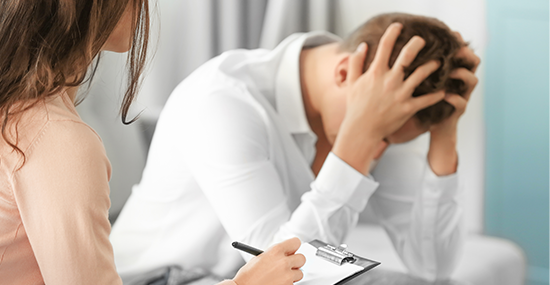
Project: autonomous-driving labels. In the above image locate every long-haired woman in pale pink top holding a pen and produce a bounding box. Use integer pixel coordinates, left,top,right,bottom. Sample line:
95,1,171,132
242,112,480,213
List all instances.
0,0,305,285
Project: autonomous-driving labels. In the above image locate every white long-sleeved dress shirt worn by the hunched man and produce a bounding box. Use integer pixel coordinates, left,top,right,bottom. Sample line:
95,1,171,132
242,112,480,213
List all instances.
111,32,461,279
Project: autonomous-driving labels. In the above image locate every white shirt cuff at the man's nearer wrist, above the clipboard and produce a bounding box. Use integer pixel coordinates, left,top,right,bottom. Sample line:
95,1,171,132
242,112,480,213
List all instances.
313,152,378,212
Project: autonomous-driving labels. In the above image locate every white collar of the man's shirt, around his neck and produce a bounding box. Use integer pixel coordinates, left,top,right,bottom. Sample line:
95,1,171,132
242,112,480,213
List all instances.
275,32,341,134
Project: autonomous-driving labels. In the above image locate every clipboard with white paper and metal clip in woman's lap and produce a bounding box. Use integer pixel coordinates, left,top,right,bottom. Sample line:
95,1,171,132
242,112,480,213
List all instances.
295,240,380,285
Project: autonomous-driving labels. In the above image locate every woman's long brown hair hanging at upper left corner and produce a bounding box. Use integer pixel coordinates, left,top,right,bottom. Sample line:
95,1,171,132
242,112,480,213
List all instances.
0,0,149,162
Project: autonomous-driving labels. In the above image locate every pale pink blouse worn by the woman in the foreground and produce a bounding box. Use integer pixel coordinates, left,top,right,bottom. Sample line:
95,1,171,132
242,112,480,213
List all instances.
0,94,122,285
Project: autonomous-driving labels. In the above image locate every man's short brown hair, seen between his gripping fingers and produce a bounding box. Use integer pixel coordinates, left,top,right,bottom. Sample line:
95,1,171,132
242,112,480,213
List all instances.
341,13,473,125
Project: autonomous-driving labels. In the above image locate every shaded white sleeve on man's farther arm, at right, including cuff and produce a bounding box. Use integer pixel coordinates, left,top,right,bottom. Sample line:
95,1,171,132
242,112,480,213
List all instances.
367,141,463,280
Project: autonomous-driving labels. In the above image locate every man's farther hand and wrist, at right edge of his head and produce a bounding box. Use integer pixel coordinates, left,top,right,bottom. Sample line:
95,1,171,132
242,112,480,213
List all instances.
428,33,481,176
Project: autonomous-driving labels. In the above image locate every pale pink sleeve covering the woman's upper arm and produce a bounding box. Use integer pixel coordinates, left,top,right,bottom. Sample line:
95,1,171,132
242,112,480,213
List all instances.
13,121,122,284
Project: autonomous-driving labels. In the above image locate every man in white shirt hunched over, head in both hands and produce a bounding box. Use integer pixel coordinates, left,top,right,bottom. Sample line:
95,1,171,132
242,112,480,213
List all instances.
111,14,479,280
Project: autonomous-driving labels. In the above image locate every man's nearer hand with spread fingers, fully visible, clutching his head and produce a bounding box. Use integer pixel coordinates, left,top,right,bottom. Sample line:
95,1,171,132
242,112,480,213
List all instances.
332,23,445,174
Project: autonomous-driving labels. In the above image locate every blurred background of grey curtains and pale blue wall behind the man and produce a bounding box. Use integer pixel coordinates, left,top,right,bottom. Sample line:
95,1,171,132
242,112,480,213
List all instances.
78,0,549,285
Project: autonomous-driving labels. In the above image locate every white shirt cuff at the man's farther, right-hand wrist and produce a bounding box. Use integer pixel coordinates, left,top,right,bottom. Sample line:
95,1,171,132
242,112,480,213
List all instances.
423,160,459,204
